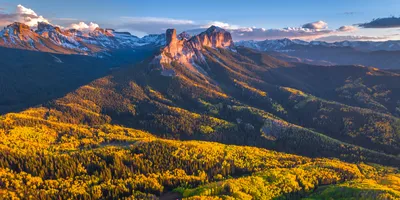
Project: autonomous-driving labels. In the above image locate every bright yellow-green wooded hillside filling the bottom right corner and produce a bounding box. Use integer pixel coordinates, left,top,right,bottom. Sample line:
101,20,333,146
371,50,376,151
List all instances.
180,161,400,200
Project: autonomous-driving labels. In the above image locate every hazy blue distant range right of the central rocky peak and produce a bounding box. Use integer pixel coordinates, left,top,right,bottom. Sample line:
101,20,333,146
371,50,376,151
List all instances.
236,39,400,69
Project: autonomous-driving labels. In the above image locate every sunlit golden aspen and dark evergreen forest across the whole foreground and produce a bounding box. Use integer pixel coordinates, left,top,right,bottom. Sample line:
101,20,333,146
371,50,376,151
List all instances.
0,108,400,199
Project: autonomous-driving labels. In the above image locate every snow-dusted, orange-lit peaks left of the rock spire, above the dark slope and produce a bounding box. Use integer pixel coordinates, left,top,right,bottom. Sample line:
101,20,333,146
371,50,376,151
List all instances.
0,22,165,56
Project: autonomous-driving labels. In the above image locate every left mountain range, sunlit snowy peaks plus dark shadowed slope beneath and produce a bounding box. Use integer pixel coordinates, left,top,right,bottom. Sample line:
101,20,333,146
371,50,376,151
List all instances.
0,22,165,114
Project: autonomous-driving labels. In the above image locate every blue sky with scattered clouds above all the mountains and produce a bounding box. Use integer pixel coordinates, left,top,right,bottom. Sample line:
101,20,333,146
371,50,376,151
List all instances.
0,0,400,42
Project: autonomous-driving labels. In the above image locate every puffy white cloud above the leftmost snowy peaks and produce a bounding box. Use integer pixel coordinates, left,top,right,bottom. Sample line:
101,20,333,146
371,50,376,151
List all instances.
0,5,50,27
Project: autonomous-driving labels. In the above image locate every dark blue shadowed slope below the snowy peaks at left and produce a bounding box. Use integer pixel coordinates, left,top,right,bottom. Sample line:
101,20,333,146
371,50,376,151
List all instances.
0,47,155,114
